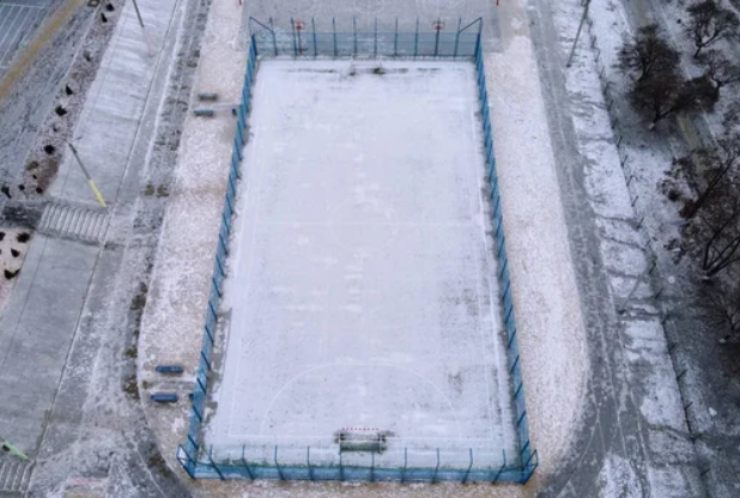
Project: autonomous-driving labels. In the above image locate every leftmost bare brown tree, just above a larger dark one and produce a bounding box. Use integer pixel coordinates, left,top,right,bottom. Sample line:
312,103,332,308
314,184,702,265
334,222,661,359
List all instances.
617,24,681,81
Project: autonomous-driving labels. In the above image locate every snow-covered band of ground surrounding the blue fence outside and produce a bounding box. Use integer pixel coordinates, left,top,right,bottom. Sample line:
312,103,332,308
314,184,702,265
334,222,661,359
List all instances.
139,0,593,497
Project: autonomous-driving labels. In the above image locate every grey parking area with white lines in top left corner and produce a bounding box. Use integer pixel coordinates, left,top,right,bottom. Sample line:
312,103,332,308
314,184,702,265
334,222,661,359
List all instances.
0,0,54,75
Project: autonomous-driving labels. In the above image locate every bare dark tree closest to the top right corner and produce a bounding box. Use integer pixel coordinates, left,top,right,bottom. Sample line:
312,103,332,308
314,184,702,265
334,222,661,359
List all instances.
686,0,740,57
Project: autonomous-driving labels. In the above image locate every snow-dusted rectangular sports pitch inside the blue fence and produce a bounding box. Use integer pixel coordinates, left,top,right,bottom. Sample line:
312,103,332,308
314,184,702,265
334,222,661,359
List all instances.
205,61,516,464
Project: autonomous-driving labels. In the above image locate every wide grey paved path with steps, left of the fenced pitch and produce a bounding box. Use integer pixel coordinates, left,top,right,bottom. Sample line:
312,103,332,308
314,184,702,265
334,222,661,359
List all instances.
0,0,205,496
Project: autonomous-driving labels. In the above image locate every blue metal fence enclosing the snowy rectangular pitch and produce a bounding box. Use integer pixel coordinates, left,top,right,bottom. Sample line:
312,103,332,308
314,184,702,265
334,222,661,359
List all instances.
177,20,538,483
